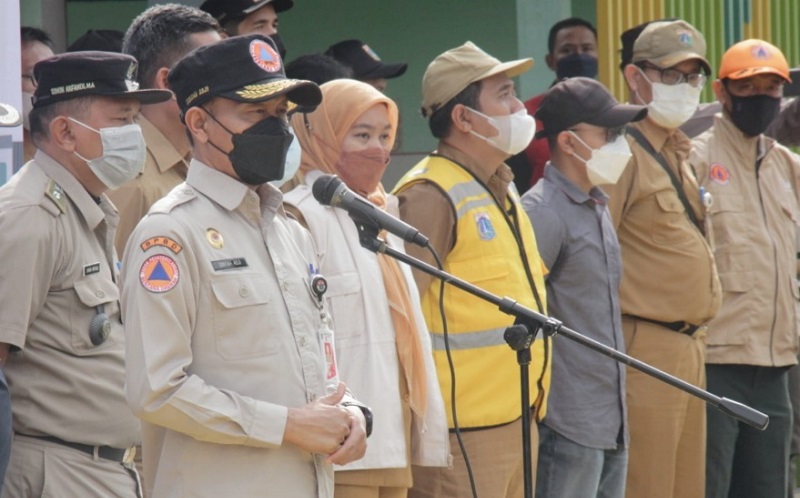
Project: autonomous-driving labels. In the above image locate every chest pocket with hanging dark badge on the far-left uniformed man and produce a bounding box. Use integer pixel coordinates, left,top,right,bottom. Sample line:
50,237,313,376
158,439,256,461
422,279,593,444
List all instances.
69,273,120,355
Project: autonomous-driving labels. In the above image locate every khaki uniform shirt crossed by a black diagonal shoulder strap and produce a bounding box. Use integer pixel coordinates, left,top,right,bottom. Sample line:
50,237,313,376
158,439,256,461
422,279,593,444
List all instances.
603,119,721,325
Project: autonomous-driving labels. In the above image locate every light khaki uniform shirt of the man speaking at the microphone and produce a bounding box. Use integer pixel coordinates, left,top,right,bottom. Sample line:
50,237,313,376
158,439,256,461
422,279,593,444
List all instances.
121,160,333,498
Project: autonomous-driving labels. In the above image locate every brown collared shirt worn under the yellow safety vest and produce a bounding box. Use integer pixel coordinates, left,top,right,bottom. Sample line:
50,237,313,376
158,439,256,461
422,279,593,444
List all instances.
397,143,514,292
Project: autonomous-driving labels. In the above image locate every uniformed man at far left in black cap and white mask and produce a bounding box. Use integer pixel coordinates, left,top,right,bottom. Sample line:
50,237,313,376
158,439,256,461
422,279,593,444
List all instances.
0,52,171,498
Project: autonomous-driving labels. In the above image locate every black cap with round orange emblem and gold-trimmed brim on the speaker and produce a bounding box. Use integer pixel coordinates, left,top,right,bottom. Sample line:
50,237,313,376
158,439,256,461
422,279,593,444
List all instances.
168,34,322,114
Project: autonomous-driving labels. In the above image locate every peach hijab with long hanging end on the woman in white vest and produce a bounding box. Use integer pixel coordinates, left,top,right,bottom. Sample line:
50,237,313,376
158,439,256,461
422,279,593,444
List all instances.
292,79,427,417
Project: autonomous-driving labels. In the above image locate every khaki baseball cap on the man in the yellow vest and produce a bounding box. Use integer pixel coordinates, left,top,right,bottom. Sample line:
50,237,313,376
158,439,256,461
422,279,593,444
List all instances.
422,41,533,118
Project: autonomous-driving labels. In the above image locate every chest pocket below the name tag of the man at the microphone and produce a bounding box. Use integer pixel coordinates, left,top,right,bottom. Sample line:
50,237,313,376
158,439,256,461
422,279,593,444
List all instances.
211,274,278,360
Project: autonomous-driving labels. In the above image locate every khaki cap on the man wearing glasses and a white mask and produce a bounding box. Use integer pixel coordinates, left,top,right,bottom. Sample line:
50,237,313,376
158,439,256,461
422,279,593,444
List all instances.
631,20,711,74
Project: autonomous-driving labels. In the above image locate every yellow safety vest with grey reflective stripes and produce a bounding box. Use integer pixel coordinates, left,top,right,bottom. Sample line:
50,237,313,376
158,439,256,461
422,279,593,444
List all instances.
395,156,550,428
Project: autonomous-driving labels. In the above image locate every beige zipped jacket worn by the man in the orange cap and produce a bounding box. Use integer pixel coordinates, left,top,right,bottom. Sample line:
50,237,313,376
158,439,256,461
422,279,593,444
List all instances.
690,114,800,367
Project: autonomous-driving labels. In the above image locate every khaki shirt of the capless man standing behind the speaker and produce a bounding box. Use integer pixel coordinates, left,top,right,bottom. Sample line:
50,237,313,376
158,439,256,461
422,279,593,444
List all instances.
108,115,189,255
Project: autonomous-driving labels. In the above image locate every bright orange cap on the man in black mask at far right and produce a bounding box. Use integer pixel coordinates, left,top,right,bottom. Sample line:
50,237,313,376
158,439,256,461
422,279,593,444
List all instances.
719,39,792,83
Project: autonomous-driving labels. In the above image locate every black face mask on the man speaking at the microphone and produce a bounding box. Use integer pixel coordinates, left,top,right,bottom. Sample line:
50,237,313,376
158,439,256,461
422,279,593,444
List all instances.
206,111,294,185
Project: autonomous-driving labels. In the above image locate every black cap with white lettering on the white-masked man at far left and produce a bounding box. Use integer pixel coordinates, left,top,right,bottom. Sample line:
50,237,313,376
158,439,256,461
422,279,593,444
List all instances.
31,51,172,109
